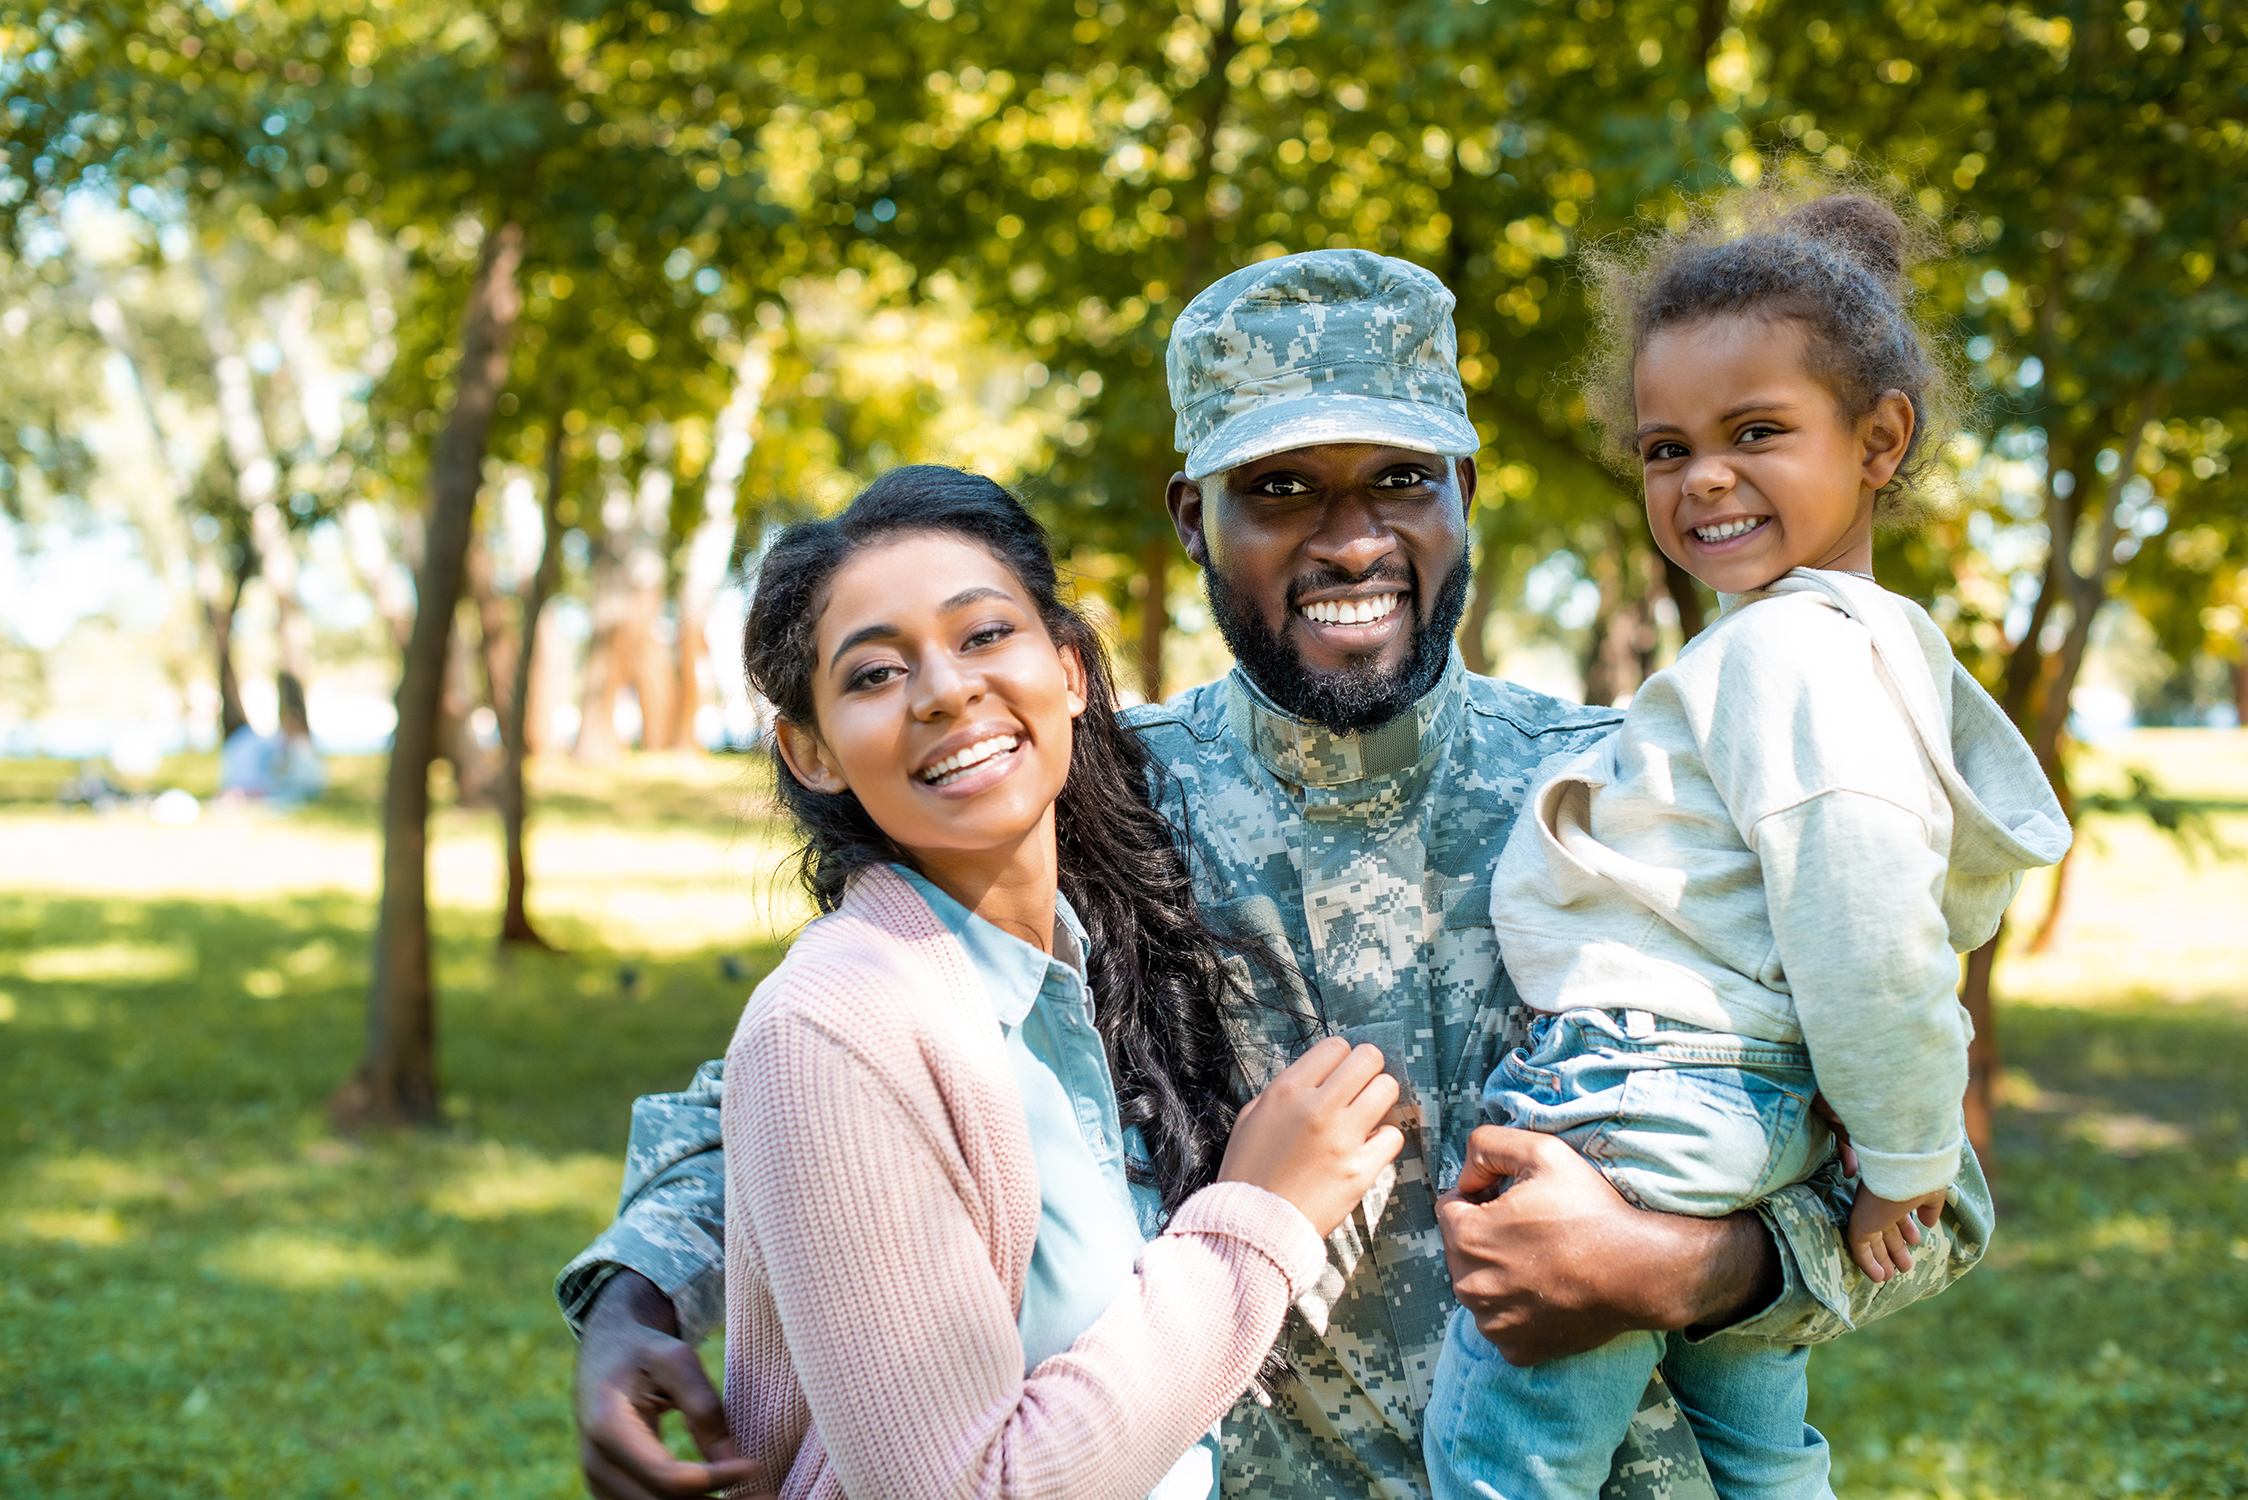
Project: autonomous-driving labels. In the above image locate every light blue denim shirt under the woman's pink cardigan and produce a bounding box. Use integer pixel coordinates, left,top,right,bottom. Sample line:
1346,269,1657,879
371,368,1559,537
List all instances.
890,866,1218,1500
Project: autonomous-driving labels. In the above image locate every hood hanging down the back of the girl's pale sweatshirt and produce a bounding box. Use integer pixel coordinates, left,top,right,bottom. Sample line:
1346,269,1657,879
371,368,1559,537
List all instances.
1762,567,2073,954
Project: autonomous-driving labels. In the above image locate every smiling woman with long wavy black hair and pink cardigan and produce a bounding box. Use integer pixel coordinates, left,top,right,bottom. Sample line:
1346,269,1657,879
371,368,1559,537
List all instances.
724,468,1403,1500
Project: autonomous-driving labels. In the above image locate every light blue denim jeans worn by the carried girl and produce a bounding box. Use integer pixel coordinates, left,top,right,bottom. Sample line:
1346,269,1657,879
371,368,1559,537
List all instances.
1421,1010,1832,1500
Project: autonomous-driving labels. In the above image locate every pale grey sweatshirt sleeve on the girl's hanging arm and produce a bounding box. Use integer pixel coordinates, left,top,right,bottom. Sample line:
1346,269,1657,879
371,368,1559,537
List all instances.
1753,792,1967,1199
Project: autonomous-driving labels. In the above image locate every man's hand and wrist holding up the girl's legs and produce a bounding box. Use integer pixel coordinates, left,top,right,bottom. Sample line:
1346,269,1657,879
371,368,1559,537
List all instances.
1436,1124,1780,1365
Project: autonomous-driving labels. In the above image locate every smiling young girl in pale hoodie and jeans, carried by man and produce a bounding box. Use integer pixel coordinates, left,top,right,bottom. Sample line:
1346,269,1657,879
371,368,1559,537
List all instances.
1423,196,2068,1500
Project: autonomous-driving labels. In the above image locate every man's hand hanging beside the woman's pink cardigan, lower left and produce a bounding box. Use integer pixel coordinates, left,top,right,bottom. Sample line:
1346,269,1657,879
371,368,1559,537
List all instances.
575,1271,773,1500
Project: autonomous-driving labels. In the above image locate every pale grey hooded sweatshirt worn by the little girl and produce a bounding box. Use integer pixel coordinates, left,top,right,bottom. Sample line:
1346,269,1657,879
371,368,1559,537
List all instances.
1490,569,2070,1199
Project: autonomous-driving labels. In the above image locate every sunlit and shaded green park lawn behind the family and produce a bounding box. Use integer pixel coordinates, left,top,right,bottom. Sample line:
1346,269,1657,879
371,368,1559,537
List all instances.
0,731,2248,1500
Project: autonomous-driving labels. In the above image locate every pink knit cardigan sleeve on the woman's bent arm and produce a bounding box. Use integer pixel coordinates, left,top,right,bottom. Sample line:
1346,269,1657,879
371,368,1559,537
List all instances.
726,1025,1324,1500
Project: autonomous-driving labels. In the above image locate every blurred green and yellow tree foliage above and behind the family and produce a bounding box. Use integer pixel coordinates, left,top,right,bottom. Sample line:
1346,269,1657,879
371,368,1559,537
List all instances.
0,0,2248,1124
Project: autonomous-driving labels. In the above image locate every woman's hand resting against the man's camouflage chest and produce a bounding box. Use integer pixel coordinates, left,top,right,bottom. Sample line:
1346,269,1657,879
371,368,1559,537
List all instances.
1218,1037,1405,1237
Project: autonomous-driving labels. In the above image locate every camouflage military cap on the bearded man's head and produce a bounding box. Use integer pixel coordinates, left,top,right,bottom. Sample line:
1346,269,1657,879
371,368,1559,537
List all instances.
1164,250,1481,479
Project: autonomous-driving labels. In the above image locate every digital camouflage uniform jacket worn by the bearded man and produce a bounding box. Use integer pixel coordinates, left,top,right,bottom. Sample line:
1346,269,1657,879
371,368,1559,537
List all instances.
555,654,1989,1500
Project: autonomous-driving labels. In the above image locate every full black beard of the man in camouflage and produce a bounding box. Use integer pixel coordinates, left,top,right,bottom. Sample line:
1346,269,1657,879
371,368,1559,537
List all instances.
1203,551,1475,735
